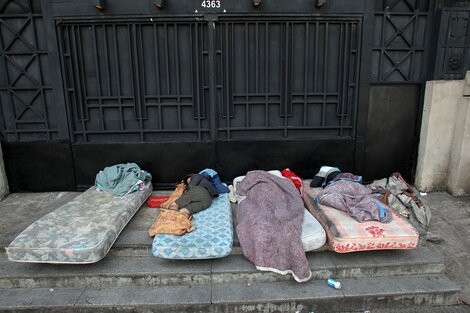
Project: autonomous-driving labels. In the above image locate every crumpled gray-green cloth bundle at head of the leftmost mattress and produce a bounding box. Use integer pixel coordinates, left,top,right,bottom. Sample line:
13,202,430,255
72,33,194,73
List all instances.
95,163,152,196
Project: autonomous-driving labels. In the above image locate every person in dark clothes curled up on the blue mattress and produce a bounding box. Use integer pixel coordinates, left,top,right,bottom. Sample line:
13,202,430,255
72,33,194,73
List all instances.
169,174,219,216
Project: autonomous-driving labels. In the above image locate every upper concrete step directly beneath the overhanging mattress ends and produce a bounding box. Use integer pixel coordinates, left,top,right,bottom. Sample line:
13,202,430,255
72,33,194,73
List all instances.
0,247,444,288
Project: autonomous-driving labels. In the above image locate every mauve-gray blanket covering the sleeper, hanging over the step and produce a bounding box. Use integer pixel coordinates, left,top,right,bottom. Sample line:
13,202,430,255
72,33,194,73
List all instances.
236,171,312,282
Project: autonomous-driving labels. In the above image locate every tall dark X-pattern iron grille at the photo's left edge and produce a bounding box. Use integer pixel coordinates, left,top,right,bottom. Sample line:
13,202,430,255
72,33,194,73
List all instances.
0,0,58,142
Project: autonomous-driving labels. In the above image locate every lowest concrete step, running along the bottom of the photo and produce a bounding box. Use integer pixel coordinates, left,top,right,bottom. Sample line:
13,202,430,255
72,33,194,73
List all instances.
0,274,459,313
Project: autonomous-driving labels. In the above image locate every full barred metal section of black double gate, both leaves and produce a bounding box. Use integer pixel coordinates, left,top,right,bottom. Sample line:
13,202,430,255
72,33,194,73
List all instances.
59,17,360,143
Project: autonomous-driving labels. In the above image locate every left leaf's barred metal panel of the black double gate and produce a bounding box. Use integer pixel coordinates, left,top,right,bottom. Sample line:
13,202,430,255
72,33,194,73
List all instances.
61,19,210,142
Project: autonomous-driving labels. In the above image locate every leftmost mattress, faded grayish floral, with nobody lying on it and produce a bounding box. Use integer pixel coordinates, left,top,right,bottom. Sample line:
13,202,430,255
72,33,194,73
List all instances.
6,183,152,264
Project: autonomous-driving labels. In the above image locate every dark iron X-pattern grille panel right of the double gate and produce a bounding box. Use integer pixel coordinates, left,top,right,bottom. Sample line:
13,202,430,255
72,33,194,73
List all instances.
371,0,429,83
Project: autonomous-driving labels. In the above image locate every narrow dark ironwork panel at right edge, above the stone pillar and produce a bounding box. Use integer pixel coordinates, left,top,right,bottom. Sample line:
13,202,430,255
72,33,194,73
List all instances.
434,6,470,79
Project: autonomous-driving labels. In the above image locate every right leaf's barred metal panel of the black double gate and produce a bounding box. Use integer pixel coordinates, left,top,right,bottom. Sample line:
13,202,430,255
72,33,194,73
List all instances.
216,18,360,139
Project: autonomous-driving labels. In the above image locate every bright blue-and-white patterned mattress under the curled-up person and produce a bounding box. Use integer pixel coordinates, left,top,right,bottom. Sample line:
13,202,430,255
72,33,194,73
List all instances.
152,193,233,259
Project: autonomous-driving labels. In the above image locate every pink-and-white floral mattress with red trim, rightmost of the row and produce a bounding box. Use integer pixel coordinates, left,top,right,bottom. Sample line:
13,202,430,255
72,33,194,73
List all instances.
303,184,419,253
